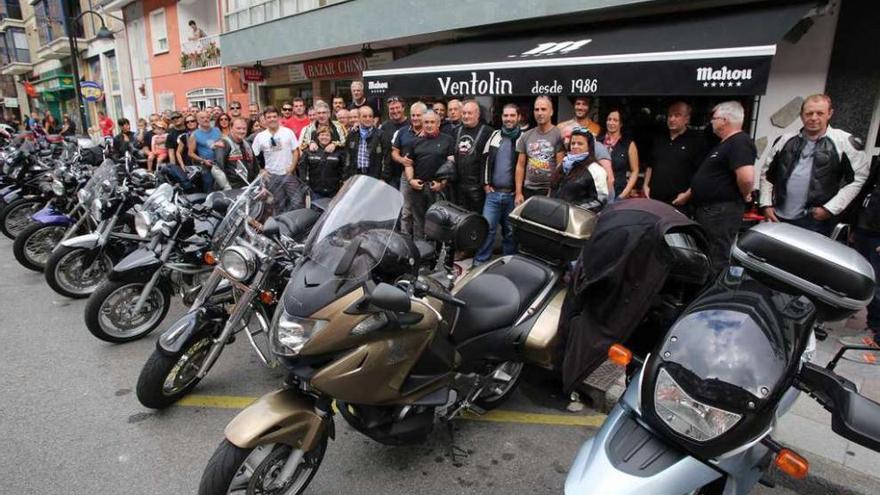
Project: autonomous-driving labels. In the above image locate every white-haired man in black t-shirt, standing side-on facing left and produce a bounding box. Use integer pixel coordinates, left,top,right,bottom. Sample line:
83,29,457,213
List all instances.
672,101,758,270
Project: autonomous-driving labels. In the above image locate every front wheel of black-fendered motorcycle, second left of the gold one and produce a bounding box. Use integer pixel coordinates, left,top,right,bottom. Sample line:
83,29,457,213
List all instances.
85,280,171,344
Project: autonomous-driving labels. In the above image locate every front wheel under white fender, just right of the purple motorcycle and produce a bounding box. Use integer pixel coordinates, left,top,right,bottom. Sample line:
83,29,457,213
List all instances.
45,246,113,299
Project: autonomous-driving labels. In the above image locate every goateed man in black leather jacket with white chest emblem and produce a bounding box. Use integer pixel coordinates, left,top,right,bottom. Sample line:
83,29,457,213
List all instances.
453,100,494,213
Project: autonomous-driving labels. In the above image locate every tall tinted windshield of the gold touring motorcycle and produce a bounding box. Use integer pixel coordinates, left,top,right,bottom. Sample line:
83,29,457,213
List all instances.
305,175,403,279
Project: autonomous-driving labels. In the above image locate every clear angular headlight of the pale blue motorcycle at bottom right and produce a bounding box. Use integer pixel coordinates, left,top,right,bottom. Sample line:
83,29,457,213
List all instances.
654,368,742,442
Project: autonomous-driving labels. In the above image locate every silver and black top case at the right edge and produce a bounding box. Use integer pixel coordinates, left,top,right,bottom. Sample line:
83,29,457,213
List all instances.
731,223,874,321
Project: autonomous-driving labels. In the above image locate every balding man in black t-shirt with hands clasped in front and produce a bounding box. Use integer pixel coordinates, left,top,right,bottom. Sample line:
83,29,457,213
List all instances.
403,110,455,239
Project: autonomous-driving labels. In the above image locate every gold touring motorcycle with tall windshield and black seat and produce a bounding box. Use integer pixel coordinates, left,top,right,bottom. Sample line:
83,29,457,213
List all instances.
199,176,595,495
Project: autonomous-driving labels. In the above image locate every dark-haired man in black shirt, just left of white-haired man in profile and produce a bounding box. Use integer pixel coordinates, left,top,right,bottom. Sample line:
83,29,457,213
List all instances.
642,101,706,207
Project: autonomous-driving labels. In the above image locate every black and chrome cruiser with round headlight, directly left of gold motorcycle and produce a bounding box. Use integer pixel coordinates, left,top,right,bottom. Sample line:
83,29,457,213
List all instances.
136,178,320,409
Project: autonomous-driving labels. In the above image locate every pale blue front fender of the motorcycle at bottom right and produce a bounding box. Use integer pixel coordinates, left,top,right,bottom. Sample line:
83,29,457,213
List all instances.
565,404,721,495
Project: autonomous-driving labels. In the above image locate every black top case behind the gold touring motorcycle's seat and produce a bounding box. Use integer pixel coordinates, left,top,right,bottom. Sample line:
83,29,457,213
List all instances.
509,196,598,263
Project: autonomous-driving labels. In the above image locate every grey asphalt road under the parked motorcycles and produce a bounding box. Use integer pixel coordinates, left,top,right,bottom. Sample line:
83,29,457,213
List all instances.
0,238,794,495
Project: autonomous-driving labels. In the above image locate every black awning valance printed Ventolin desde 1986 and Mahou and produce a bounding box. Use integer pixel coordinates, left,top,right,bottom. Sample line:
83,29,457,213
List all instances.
365,57,771,97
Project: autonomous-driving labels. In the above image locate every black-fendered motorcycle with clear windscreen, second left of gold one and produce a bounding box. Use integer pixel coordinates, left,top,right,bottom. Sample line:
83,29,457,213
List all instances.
84,183,221,343
